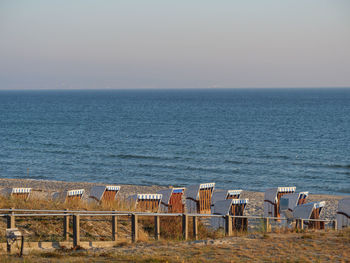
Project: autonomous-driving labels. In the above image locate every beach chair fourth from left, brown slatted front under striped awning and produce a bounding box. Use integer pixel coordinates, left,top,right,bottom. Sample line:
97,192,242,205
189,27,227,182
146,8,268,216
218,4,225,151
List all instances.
129,194,162,213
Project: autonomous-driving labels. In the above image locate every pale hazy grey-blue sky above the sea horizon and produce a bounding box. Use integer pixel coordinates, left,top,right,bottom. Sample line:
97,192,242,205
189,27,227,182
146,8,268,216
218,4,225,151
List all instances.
0,0,350,89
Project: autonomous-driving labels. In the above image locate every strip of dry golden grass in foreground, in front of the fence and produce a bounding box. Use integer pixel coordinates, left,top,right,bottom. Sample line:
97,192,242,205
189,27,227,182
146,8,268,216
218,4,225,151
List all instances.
0,229,350,262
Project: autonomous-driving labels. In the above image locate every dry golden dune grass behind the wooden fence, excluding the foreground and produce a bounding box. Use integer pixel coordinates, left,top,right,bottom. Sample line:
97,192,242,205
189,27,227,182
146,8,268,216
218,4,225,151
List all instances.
0,196,222,242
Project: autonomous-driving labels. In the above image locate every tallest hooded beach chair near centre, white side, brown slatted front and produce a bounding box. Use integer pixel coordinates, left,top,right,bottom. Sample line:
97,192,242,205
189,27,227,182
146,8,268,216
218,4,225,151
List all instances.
186,183,215,214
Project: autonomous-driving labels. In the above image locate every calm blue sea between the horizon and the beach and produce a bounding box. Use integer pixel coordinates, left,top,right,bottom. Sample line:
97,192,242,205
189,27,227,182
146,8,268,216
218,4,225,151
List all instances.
0,89,350,194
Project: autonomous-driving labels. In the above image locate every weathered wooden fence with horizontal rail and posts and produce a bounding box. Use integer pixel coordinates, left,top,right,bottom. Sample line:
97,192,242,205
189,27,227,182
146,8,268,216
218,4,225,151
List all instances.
0,208,337,252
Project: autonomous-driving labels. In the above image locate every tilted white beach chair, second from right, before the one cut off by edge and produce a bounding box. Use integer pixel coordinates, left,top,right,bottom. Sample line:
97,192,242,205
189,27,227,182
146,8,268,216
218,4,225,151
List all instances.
293,201,326,229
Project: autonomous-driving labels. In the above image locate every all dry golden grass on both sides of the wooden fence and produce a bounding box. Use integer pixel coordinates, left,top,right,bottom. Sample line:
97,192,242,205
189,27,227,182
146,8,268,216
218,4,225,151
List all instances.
0,197,350,262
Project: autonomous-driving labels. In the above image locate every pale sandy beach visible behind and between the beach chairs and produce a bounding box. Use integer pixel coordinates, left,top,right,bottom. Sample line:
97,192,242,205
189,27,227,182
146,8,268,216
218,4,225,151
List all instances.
0,179,348,220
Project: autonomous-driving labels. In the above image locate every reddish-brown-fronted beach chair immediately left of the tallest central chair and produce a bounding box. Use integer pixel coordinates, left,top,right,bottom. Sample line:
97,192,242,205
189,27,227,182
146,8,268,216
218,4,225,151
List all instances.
158,188,185,213
